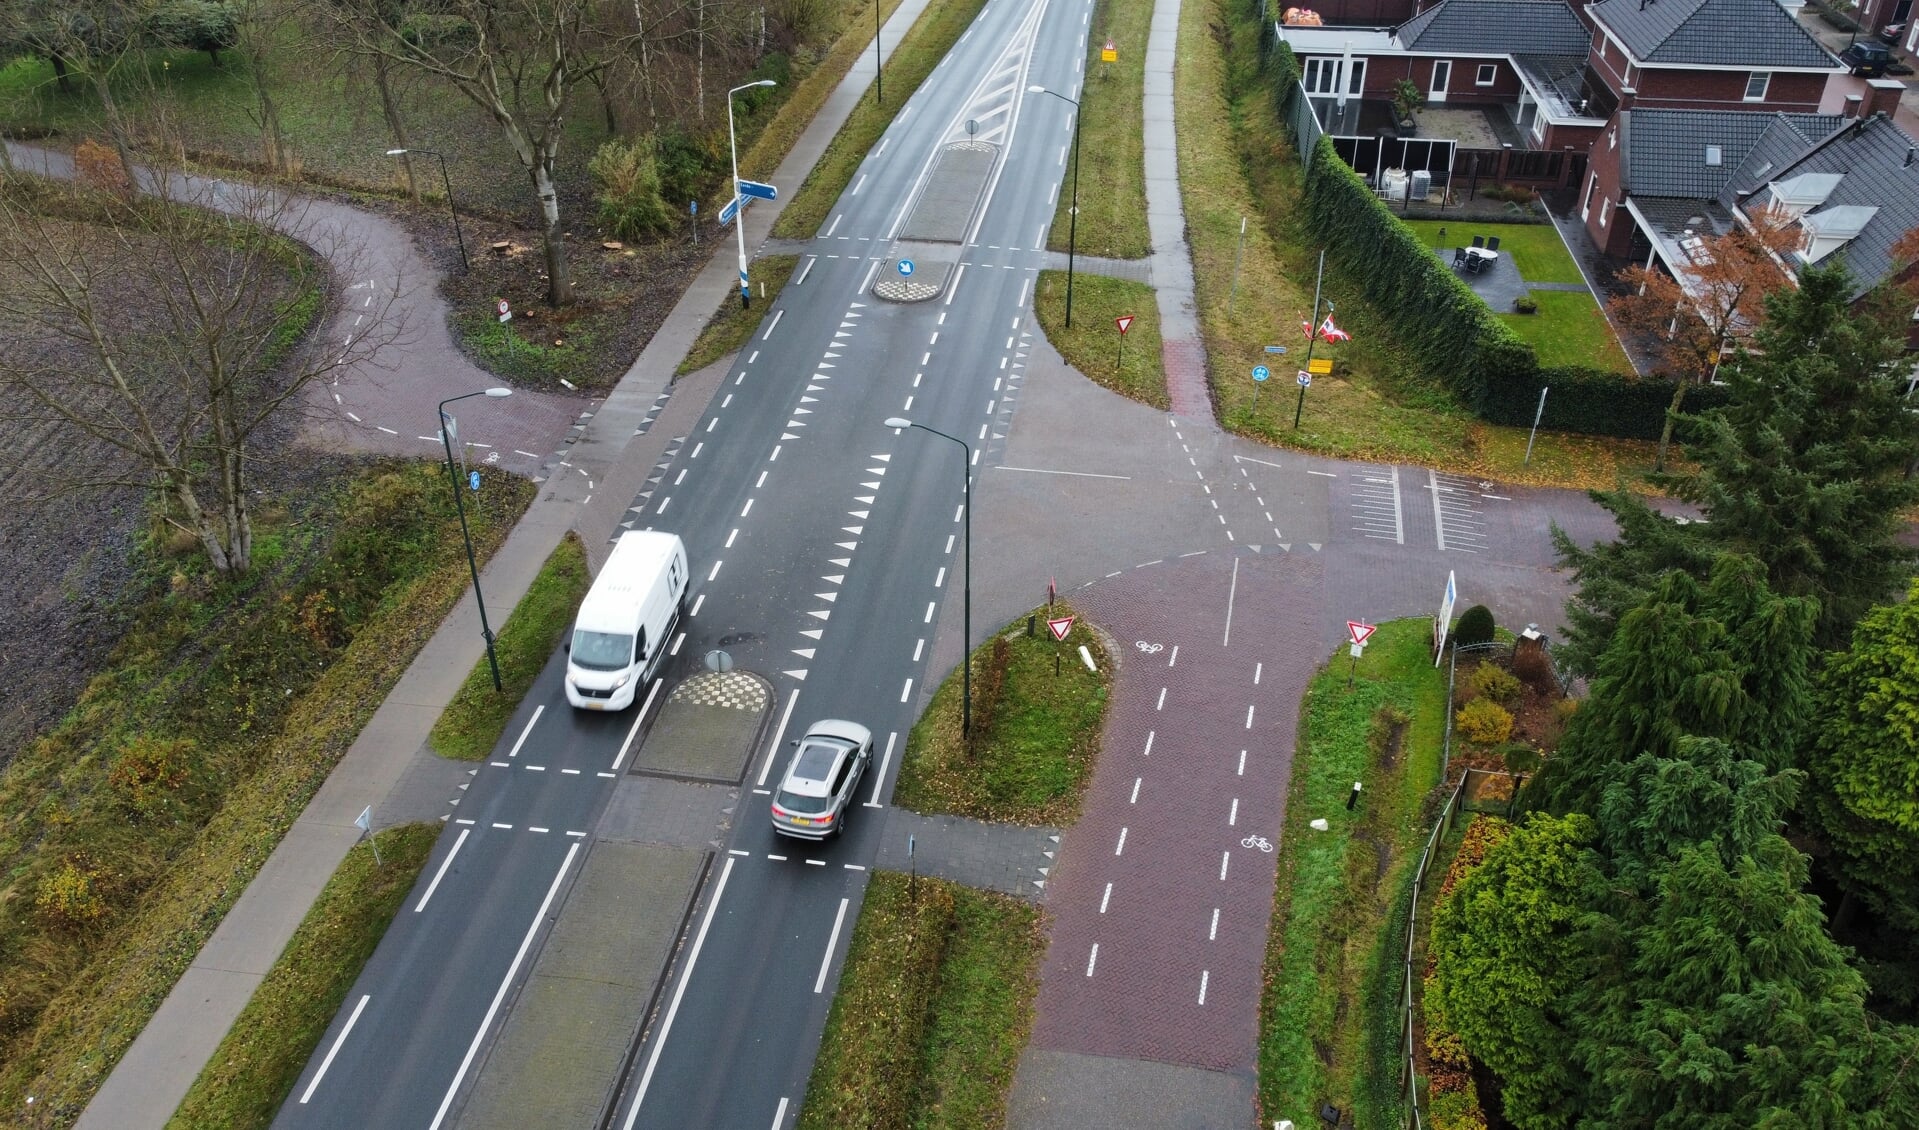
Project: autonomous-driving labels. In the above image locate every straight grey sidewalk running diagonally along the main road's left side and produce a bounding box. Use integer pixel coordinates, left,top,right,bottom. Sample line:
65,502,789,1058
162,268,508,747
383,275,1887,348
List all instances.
77,0,927,1130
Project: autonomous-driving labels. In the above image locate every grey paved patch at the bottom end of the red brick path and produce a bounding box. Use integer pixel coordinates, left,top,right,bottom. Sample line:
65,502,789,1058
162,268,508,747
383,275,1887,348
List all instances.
1006,1048,1253,1130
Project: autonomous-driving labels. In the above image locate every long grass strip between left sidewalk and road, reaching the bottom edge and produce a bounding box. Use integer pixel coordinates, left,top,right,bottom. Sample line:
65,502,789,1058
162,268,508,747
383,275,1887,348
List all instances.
167,823,439,1130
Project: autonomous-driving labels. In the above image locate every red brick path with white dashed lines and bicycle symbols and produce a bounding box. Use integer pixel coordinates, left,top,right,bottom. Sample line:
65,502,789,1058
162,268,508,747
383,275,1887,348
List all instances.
1032,551,1324,1072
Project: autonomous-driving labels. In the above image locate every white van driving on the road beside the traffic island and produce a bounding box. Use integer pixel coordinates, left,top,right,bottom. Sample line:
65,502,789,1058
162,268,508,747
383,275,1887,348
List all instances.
566,530,687,710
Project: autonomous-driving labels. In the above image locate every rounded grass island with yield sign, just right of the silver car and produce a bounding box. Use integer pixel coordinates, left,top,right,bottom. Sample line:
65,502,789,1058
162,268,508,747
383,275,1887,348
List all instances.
892,602,1113,825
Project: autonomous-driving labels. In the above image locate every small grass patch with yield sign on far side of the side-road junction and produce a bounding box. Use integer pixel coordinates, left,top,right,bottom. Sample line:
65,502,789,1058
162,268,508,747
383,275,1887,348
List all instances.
1032,271,1173,409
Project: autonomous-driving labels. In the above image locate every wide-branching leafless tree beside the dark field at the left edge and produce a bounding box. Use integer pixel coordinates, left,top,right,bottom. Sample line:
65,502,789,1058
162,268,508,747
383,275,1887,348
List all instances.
0,169,393,574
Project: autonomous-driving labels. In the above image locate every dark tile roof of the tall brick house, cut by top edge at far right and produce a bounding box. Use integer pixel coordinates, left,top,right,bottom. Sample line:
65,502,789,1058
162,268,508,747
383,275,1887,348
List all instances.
1585,0,1840,71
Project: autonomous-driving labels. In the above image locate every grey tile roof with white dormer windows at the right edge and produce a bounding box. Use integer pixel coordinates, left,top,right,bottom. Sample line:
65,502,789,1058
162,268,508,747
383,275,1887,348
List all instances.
1721,113,1919,297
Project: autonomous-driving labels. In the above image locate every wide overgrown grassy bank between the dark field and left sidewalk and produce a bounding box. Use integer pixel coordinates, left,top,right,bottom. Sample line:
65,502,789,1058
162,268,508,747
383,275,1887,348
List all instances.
0,462,533,1126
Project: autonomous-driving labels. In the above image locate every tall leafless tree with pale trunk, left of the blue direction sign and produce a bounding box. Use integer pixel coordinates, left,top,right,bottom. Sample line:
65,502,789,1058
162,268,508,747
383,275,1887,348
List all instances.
330,0,610,307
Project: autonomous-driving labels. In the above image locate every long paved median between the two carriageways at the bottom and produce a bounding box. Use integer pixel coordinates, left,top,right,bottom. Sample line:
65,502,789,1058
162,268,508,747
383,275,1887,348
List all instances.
459,840,708,1130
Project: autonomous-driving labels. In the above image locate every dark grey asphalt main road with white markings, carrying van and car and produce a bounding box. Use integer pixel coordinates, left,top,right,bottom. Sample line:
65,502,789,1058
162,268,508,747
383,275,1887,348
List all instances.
276,0,1092,1128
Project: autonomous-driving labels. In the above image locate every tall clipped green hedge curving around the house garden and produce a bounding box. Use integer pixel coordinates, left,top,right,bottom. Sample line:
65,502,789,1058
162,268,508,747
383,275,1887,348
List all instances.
1267,42,1725,439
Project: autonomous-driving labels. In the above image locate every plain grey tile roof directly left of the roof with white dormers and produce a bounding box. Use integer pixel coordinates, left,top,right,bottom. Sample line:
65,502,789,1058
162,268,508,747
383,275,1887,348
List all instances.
1620,109,1844,200
